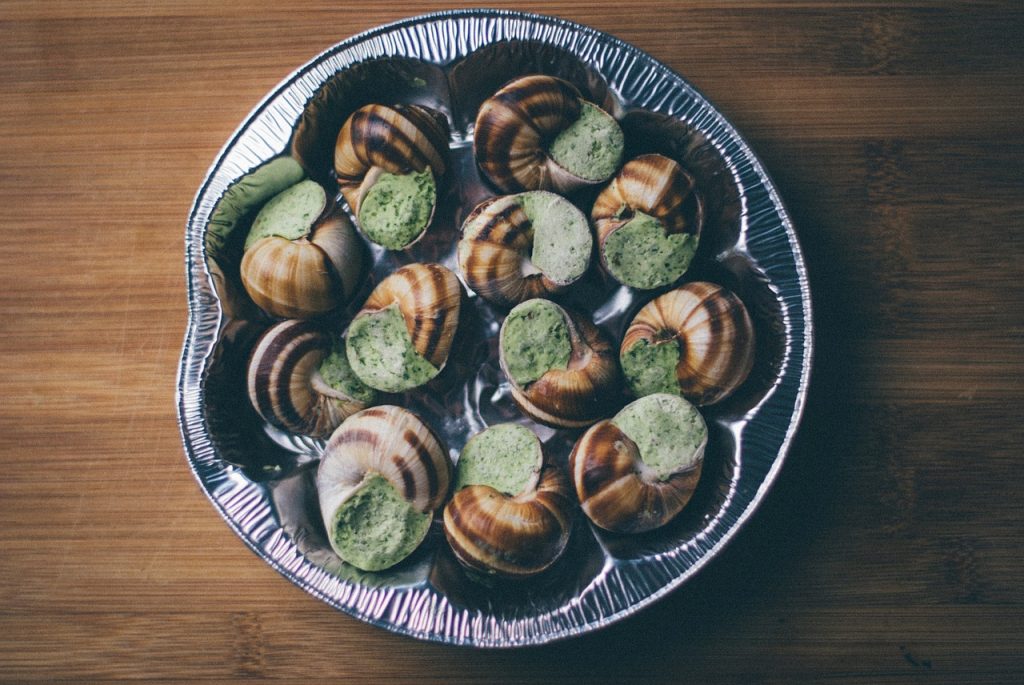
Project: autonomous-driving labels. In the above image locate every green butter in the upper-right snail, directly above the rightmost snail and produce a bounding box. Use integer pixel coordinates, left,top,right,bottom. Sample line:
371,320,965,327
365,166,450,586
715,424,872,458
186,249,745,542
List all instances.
601,212,697,290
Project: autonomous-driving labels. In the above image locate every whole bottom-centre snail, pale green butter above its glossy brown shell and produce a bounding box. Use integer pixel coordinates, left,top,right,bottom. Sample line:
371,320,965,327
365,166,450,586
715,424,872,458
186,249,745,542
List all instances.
444,424,574,577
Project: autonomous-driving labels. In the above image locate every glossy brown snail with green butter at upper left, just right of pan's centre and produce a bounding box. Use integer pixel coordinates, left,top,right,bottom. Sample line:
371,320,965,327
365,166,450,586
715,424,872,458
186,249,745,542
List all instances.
499,299,620,428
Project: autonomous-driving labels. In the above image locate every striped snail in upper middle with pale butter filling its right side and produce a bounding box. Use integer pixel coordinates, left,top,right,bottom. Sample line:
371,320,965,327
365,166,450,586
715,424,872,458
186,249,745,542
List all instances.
458,191,592,307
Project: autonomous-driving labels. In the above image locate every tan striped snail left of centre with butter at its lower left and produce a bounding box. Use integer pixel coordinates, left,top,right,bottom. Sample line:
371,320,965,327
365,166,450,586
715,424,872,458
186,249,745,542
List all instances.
347,263,462,392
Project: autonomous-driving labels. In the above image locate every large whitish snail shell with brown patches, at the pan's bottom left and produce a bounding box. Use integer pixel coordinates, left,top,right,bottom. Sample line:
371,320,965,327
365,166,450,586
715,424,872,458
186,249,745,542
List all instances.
316,405,452,570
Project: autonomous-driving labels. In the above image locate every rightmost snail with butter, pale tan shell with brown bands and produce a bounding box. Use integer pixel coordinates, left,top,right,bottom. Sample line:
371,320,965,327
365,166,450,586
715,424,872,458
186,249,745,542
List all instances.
620,282,755,405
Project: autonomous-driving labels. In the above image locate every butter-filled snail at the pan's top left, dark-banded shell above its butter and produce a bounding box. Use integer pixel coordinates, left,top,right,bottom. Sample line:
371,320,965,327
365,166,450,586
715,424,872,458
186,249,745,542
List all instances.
334,104,449,250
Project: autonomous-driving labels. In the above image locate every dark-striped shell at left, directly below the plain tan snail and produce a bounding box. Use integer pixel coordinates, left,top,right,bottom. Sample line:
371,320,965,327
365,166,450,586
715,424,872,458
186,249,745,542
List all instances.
246,319,374,437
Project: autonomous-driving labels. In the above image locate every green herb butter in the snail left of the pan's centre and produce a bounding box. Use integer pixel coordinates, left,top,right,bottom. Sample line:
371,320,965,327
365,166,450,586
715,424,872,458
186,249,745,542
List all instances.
346,304,439,392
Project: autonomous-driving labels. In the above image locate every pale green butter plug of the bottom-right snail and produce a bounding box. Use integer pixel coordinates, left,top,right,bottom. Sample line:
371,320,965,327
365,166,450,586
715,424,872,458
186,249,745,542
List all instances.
611,393,708,480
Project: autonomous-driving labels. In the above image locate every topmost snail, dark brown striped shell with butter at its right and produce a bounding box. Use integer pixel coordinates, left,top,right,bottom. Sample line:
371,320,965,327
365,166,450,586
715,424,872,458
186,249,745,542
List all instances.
473,75,623,194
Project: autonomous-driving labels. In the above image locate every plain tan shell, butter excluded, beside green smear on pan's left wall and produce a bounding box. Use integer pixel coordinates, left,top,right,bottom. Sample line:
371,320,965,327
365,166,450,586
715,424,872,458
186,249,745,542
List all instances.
241,181,364,318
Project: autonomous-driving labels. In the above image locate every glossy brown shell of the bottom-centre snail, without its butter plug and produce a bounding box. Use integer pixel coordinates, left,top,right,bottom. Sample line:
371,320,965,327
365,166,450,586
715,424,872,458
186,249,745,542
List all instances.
444,463,574,577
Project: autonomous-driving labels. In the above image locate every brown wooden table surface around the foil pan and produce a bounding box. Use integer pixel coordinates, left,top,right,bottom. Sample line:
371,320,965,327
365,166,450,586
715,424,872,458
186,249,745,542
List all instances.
0,0,1024,684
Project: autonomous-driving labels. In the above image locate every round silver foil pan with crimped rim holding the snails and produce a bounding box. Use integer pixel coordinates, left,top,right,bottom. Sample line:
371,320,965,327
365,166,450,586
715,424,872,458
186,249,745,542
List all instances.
177,10,812,647
